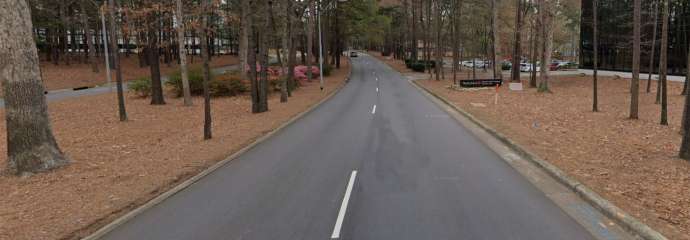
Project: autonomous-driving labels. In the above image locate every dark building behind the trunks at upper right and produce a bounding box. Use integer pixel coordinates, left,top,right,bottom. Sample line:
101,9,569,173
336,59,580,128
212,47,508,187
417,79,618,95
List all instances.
580,0,690,75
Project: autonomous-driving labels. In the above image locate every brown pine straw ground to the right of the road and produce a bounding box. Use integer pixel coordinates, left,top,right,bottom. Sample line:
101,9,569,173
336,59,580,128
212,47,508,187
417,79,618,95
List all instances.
420,73,690,239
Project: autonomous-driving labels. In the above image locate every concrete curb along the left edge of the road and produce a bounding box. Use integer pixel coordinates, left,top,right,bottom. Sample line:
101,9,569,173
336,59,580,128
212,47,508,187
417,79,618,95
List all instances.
82,60,352,240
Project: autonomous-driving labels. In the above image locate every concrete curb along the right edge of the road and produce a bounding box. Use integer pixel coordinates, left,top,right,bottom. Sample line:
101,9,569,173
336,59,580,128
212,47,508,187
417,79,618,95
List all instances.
409,80,667,240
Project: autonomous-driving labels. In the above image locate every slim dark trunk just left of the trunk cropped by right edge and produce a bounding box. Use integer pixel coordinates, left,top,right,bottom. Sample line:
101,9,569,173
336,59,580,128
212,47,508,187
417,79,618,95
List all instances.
659,0,670,125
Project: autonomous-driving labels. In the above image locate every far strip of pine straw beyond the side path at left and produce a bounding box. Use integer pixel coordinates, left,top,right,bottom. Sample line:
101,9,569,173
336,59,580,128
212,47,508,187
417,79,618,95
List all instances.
36,54,239,90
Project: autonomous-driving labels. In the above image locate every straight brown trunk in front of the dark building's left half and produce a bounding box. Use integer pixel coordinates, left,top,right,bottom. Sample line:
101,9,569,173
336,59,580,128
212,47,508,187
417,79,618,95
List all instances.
630,0,642,119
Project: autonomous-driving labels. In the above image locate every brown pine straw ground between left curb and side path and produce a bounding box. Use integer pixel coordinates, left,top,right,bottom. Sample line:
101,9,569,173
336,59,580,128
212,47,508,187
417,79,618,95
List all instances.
0,57,349,240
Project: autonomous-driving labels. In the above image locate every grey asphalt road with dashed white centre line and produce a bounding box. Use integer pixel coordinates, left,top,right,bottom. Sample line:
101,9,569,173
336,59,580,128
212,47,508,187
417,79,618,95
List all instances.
103,56,593,240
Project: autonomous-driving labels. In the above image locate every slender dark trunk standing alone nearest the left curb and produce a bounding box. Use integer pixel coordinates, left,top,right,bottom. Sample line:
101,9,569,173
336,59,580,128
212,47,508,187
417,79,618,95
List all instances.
200,0,213,140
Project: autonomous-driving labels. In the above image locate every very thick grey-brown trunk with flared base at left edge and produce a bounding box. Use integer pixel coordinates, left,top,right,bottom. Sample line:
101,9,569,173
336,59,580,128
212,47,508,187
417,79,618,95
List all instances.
0,0,69,174
